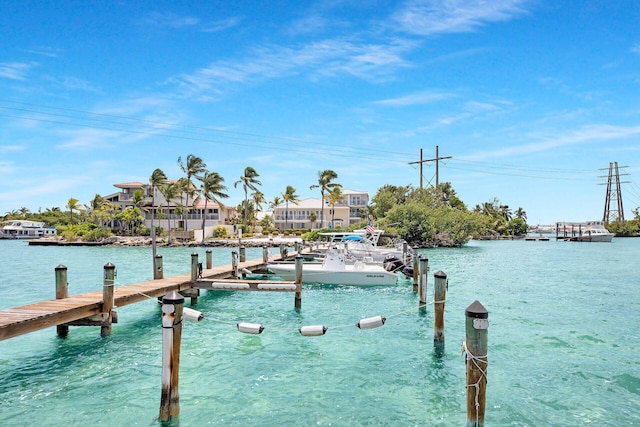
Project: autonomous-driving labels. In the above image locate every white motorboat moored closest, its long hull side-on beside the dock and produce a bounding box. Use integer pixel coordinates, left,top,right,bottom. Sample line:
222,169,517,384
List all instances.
267,252,398,286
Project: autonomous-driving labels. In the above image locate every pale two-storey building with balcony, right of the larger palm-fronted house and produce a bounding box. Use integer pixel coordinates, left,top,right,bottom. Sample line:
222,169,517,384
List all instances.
273,190,369,231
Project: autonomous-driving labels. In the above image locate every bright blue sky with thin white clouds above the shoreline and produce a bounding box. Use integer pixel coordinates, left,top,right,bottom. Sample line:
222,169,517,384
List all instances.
0,0,640,224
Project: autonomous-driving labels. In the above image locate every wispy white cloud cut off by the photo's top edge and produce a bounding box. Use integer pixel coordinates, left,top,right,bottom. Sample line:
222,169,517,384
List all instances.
392,0,527,35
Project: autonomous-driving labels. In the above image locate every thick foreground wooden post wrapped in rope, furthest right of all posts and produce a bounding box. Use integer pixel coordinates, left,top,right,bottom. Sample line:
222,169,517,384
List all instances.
464,301,489,427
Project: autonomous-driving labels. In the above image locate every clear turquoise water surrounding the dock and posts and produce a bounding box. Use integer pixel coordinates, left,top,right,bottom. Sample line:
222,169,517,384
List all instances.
0,238,640,426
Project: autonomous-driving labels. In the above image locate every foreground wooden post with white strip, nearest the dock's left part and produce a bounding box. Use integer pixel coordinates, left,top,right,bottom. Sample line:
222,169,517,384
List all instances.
160,291,184,421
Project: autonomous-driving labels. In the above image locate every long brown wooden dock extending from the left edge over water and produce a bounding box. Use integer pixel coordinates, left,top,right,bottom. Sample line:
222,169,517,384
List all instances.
0,249,304,341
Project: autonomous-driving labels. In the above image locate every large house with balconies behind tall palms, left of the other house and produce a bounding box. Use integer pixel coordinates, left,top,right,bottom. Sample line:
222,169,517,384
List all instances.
104,181,238,237
